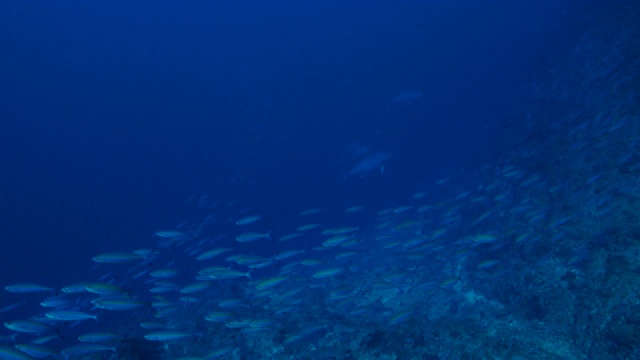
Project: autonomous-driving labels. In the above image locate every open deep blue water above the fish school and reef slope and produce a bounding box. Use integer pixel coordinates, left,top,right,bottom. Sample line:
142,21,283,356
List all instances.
0,0,571,286
